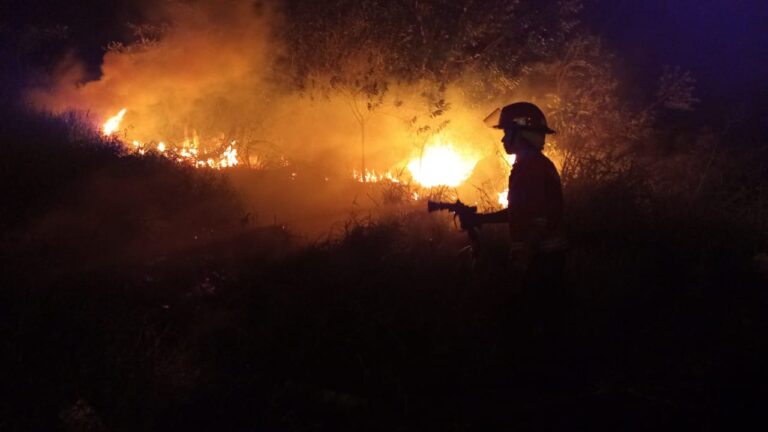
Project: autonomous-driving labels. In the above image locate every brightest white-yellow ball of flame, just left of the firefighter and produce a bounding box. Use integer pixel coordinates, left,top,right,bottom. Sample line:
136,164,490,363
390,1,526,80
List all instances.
408,137,478,187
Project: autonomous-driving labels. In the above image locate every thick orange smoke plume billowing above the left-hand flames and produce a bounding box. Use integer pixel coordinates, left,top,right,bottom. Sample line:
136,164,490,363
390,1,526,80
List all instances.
30,1,274,147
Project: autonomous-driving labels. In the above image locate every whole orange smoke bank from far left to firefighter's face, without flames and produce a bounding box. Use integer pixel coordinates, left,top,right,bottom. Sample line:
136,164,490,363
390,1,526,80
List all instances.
28,0,528,233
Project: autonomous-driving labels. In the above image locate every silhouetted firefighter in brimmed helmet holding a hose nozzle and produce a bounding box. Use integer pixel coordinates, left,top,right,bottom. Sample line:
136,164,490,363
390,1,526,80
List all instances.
462,102,567,303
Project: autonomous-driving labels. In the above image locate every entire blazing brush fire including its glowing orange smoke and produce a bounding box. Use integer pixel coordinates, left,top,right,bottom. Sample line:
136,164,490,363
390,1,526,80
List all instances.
34,2,525,215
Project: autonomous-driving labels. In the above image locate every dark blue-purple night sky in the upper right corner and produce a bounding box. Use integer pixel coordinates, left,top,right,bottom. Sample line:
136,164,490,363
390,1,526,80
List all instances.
585,0,768,104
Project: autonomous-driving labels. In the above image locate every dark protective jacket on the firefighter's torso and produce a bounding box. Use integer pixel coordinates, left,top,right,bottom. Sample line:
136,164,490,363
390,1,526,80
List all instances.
507,152,567,254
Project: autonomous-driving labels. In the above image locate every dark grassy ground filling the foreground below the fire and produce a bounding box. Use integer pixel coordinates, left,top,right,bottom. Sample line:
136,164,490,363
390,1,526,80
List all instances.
0,105,767,431
